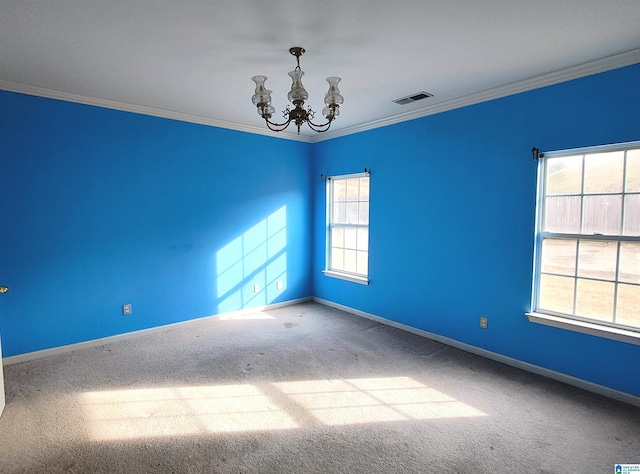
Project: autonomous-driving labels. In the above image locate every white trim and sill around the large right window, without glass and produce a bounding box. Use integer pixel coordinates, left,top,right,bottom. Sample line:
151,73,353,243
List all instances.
525,141,640,345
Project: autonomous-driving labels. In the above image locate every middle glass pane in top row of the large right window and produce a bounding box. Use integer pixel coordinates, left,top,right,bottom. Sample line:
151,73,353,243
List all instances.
584,151,624,194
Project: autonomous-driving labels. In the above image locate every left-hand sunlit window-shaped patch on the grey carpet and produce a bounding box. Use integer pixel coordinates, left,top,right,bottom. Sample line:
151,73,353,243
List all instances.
81,385,298,441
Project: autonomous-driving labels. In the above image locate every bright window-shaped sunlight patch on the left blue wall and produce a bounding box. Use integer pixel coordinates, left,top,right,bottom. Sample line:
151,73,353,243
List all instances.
216,206,287,313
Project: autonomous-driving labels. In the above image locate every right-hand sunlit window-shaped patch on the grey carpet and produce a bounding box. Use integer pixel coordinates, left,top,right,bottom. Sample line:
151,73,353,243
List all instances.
274,377,486,425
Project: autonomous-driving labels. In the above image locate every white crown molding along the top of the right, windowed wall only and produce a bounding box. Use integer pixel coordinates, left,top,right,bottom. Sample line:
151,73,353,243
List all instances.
310,49,640,143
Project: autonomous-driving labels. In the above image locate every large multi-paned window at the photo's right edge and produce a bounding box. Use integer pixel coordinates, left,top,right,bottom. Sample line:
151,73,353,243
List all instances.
530,143,640,336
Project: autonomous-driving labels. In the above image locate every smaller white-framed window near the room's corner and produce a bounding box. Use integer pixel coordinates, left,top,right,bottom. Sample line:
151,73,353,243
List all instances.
324,172,369,285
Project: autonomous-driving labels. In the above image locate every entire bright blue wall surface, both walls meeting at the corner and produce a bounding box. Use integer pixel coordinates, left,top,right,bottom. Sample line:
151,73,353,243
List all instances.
0,65,640,396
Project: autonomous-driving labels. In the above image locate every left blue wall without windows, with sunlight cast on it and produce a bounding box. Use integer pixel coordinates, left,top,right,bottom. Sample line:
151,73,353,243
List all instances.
0,92,311,357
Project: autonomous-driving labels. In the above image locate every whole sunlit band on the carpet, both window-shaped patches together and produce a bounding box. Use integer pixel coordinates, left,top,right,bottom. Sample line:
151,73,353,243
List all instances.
79,377,487,441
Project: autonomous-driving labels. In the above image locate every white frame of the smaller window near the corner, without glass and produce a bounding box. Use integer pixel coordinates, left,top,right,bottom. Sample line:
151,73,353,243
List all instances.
322,170,371,285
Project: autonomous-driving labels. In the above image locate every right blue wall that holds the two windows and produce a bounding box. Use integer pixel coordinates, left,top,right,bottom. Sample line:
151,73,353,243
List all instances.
312,65,640,396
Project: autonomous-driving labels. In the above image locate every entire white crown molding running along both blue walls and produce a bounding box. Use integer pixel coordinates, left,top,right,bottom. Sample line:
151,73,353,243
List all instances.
0,49,640,143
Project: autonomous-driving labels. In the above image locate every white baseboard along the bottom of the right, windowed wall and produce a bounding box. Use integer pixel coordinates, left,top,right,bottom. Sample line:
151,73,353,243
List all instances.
313,296,640,407
